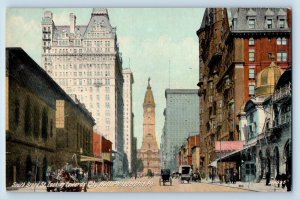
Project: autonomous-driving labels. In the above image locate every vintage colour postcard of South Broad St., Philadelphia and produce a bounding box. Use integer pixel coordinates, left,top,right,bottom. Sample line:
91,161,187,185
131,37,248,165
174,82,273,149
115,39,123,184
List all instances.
5,8,293,192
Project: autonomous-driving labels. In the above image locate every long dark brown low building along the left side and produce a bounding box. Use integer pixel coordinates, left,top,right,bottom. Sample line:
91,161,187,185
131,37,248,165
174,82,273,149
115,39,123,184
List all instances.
6,48,95,186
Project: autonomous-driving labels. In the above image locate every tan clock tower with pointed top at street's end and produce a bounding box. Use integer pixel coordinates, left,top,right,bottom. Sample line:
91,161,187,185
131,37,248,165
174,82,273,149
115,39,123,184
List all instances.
138,78,160,174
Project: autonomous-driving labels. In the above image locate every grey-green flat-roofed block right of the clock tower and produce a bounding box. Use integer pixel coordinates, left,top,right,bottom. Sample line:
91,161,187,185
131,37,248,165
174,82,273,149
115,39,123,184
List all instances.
160,89,199,171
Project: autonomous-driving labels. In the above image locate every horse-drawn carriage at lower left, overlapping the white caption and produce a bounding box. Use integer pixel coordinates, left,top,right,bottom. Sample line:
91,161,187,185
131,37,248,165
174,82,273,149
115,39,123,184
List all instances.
46,168,87,192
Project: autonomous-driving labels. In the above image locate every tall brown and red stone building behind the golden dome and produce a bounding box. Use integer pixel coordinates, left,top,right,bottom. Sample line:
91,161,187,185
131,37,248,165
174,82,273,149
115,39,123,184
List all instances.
197,8,291,174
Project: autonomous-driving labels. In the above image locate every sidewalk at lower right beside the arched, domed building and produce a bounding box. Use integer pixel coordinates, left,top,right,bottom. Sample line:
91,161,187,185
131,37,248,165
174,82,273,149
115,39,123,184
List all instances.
201,179,287,192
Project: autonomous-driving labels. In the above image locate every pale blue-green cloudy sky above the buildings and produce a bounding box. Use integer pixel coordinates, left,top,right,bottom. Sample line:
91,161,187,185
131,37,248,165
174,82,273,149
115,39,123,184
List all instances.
6,8,204,148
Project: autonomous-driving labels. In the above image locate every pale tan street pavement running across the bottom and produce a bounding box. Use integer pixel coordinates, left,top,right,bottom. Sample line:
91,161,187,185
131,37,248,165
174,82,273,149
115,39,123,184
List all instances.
8,176,286,192
